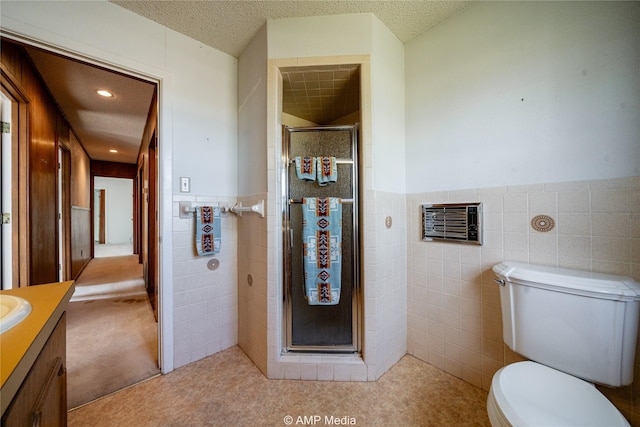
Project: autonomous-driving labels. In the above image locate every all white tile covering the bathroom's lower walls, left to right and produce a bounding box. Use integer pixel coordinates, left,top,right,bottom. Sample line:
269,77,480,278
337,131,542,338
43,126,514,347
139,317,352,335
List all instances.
178,178,640,394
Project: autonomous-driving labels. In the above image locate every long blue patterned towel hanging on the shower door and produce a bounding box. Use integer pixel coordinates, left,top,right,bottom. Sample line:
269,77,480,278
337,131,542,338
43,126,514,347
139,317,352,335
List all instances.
302,197,342,305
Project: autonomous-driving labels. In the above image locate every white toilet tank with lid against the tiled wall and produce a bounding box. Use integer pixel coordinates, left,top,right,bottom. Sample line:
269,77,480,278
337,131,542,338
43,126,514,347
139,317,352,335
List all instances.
493,262,640,387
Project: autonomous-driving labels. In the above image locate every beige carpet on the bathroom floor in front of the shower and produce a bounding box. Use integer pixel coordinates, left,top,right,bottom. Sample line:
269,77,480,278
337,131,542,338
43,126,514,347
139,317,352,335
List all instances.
68,347,489,427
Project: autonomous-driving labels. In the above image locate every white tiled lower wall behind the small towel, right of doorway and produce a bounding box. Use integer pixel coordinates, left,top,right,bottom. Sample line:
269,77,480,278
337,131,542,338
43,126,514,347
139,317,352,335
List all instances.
173,195,238,368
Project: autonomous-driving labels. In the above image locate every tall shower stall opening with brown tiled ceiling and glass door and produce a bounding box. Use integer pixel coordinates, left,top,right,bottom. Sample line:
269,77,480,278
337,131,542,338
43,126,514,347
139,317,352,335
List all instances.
278,61,363,355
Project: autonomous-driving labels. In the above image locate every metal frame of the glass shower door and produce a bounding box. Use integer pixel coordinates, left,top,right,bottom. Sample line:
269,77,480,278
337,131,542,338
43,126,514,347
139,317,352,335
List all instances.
281,123,362,354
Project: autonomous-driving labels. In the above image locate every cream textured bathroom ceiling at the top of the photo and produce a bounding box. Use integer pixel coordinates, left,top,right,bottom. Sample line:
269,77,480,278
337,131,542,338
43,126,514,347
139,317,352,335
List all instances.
110,0,470,57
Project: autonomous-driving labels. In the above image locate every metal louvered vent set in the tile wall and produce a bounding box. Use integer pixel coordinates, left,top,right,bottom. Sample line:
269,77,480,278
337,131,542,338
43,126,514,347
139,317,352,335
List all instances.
422,203,482,245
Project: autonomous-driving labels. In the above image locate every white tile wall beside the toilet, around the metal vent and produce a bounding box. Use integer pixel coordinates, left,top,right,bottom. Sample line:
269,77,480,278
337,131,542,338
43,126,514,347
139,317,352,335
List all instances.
407,177,640,389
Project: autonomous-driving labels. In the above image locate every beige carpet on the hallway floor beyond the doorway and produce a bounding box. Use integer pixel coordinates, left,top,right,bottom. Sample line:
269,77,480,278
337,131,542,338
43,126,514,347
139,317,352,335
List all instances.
67,255,159,408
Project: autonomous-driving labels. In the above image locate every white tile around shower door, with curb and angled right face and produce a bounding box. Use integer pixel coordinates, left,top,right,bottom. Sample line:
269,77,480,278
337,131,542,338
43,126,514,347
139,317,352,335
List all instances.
260,187,407,381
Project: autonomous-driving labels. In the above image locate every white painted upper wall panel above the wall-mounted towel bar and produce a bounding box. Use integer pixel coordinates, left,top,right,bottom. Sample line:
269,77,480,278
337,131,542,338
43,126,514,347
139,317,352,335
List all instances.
166,33,238,197
